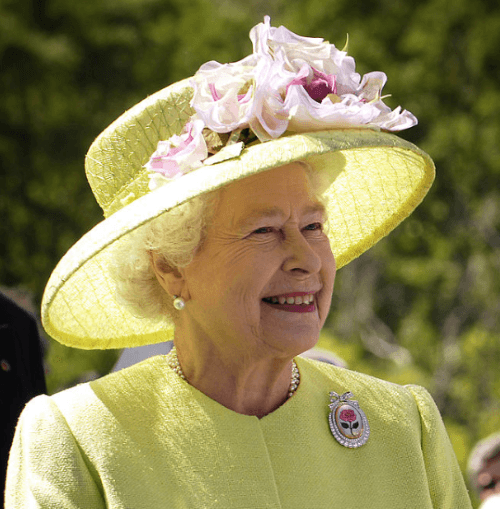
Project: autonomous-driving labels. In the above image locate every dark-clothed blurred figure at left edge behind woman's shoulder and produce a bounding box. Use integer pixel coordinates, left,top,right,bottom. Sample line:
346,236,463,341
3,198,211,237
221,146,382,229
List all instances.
0,292,47,507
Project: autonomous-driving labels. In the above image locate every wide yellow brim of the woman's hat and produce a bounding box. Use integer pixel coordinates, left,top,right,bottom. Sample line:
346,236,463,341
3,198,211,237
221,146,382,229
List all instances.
42,129,434,349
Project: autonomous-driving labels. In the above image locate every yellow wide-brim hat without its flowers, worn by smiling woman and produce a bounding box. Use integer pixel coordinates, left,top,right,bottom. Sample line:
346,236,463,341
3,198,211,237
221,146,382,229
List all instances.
42,25,434,349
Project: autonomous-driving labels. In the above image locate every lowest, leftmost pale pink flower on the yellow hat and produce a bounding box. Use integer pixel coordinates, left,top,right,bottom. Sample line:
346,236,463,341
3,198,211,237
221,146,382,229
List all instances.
145,119,208,190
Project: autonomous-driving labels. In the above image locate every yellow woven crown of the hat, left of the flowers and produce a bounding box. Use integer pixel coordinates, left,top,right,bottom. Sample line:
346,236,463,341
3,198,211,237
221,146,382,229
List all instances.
85,80,194,217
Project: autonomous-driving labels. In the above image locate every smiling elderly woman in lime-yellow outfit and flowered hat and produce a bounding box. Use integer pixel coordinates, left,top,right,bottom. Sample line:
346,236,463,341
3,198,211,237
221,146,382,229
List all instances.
6,17,470,509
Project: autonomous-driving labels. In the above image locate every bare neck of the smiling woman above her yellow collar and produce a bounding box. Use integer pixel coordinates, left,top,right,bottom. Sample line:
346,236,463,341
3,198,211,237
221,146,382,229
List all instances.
170,342,298,418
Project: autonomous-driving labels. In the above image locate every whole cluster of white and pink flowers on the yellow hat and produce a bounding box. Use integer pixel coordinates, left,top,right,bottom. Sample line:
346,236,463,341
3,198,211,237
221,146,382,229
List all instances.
146,16,417,189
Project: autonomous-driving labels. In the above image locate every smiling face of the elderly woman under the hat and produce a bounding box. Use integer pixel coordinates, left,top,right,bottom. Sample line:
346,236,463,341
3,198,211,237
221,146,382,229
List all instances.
177,163,336,357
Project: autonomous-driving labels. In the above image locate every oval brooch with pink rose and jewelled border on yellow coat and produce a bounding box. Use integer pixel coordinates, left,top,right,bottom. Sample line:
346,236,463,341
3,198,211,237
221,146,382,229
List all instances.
328,391,370,448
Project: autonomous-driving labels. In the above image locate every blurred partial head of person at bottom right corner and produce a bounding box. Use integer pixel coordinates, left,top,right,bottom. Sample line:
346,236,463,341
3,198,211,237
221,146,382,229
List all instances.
467,433,500,509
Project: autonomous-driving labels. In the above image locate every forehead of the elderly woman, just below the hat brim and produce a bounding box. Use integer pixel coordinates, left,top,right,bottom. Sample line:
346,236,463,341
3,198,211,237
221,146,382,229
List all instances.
217,163,324,223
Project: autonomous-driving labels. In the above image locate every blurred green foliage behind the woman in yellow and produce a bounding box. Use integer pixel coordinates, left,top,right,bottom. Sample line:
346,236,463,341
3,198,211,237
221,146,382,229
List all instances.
0,0,500,500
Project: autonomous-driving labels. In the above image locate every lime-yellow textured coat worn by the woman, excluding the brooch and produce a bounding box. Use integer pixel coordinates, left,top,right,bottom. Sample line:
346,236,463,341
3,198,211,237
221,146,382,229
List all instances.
6,357,471,509
